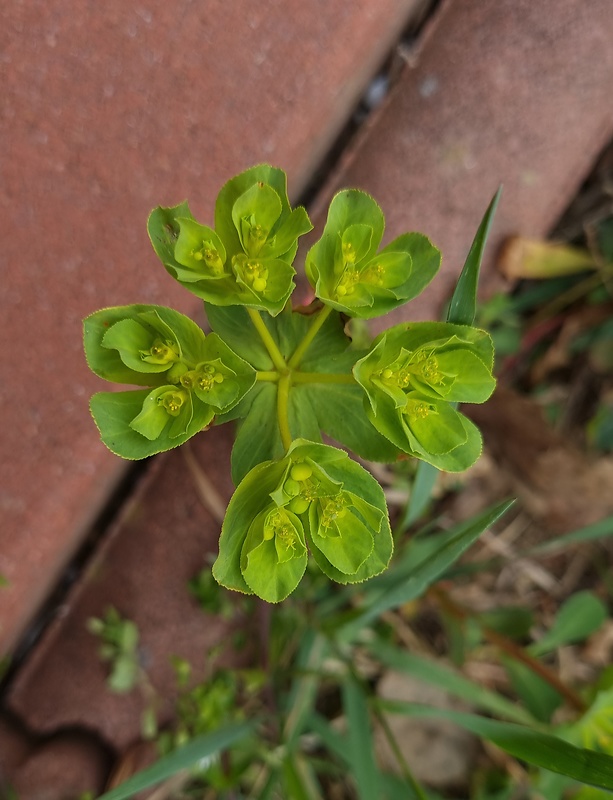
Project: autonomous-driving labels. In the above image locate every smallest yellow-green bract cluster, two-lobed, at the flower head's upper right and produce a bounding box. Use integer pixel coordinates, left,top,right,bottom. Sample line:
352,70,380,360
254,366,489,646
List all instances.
305,189,441,319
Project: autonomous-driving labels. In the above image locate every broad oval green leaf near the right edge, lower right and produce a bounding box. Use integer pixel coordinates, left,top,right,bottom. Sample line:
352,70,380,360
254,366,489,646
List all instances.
528,591,607,656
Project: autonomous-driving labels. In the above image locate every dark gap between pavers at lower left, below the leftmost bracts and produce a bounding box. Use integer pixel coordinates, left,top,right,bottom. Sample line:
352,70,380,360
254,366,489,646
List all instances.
0,456,151,710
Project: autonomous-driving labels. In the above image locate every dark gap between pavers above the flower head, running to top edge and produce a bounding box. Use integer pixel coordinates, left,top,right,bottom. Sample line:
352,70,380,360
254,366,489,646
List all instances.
296,0,445,208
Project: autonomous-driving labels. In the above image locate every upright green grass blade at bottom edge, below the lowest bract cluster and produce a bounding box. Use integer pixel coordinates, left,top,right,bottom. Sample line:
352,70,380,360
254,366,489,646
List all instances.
342,676,380,800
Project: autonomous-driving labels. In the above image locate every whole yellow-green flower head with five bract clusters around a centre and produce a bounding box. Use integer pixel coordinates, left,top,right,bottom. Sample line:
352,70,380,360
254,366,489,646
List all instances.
84,165,495,603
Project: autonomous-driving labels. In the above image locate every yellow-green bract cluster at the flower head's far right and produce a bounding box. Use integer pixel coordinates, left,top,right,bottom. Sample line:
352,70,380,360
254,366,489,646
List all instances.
354,322,495,472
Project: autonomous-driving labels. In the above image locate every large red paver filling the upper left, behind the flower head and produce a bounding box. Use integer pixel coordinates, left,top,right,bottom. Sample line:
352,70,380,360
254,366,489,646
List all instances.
0,0,415,652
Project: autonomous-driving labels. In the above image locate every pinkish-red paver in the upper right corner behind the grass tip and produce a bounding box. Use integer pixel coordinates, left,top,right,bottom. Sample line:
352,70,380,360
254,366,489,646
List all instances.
316,0,613,326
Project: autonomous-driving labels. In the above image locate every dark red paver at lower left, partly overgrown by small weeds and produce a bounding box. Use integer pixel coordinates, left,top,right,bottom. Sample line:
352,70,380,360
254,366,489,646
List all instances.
9,425,239,749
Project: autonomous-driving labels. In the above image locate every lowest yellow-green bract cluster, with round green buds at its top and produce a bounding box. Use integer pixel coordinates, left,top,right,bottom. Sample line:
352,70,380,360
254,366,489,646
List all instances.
213,439,393,603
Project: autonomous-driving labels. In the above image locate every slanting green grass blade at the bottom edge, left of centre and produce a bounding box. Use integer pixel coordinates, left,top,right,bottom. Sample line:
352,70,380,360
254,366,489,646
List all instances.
98,722,254,800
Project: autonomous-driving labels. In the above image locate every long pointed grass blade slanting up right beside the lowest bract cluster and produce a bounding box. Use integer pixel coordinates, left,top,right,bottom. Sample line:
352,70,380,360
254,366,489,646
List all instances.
343,501,513,638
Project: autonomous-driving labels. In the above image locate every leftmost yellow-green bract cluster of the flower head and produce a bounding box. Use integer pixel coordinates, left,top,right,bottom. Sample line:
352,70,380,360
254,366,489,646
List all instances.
84,305,255,458
